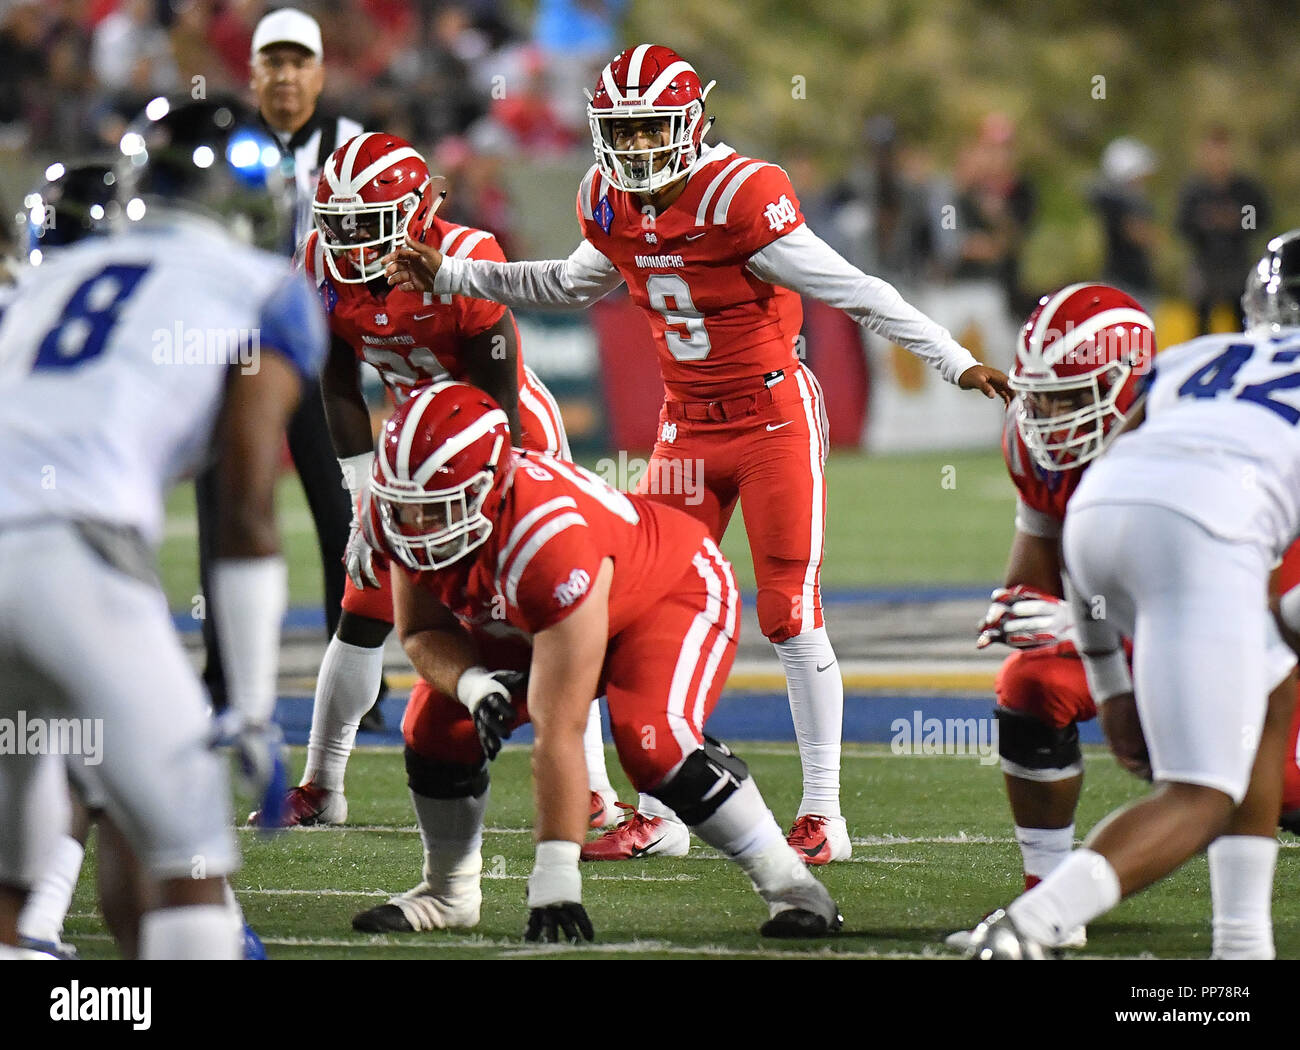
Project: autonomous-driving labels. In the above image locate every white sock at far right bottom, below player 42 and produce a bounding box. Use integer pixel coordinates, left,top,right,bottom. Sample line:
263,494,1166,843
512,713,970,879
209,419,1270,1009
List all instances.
1206,834,1278,959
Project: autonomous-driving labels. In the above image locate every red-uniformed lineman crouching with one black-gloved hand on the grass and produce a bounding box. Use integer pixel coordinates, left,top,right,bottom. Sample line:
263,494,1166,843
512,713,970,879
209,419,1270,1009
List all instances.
354,382,841,941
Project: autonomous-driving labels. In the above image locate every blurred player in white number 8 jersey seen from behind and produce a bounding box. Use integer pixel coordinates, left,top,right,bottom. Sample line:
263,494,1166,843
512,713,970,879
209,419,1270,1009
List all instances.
0,99,325,959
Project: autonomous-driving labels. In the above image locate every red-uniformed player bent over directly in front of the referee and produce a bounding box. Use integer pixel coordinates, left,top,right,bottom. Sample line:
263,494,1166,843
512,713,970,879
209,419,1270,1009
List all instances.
254,133,618,828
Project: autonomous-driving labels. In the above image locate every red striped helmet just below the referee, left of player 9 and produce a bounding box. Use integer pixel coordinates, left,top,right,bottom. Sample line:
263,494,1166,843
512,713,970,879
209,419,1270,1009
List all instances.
312,131,429,285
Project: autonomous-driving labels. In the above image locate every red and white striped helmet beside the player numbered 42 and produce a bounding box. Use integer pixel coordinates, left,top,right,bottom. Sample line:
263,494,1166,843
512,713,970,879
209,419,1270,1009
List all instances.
1010,285,1156,470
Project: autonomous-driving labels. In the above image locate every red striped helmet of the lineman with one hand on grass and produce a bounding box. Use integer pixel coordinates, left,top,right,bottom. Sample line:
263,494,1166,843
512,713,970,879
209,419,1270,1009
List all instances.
371,382,511,570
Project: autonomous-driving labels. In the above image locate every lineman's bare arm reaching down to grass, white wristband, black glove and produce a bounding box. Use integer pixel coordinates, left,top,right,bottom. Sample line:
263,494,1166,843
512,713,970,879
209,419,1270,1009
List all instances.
524,557,614,941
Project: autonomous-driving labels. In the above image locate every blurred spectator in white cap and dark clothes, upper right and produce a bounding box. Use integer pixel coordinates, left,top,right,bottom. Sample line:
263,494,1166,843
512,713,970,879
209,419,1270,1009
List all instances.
1089,138,1160,309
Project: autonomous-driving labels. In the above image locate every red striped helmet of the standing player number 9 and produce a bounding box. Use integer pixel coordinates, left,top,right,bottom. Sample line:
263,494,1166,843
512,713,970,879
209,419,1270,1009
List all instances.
586,44,714,194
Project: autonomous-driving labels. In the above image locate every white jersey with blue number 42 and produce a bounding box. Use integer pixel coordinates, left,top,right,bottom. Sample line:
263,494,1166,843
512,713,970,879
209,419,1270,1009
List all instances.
1070,330,1300,556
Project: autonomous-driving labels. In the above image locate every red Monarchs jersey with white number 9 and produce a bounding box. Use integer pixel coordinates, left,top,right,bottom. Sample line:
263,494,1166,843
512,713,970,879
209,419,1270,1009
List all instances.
577,146,803,400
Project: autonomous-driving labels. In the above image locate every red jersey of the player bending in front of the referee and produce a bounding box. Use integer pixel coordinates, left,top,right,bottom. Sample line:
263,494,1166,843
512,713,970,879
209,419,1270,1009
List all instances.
303,216,524,404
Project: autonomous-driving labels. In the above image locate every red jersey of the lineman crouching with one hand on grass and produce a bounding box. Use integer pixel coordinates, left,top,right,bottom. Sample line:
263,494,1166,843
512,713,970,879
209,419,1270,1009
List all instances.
369,448,707,639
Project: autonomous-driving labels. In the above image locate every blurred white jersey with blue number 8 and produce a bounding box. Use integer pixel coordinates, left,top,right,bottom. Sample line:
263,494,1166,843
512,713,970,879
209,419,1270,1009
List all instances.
0,217,326,543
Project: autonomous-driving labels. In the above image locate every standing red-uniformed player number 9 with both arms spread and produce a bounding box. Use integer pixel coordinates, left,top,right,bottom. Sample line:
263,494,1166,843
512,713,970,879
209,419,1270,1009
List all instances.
386,44,1010,864
